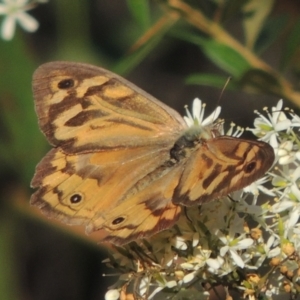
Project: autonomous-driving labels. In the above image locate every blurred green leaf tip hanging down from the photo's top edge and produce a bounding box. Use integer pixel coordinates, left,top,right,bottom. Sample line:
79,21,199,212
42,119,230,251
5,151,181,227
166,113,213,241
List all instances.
127,0,150,31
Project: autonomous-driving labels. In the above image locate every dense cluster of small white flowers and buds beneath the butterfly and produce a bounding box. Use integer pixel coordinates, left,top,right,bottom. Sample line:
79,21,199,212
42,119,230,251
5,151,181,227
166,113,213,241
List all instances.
105,99,300,300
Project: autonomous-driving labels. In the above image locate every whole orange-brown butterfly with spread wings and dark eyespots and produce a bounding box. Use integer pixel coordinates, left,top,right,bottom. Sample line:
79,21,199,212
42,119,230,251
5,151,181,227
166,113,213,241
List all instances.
31,62,274,245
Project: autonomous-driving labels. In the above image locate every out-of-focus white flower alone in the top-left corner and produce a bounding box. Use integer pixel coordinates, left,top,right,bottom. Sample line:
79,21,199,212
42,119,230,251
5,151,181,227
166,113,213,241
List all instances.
0,0,39,40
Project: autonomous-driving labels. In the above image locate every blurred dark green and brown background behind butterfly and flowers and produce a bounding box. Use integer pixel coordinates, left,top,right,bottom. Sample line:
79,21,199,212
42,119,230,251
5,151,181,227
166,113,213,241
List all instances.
0,0,300,300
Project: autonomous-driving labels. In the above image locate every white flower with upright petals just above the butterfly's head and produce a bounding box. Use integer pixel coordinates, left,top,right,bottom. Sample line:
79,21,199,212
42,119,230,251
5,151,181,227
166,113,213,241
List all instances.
183,98,221,127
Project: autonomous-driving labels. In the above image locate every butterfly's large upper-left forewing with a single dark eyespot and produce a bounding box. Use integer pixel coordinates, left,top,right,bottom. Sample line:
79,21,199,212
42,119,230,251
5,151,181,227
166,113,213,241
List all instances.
33,62,186,153
